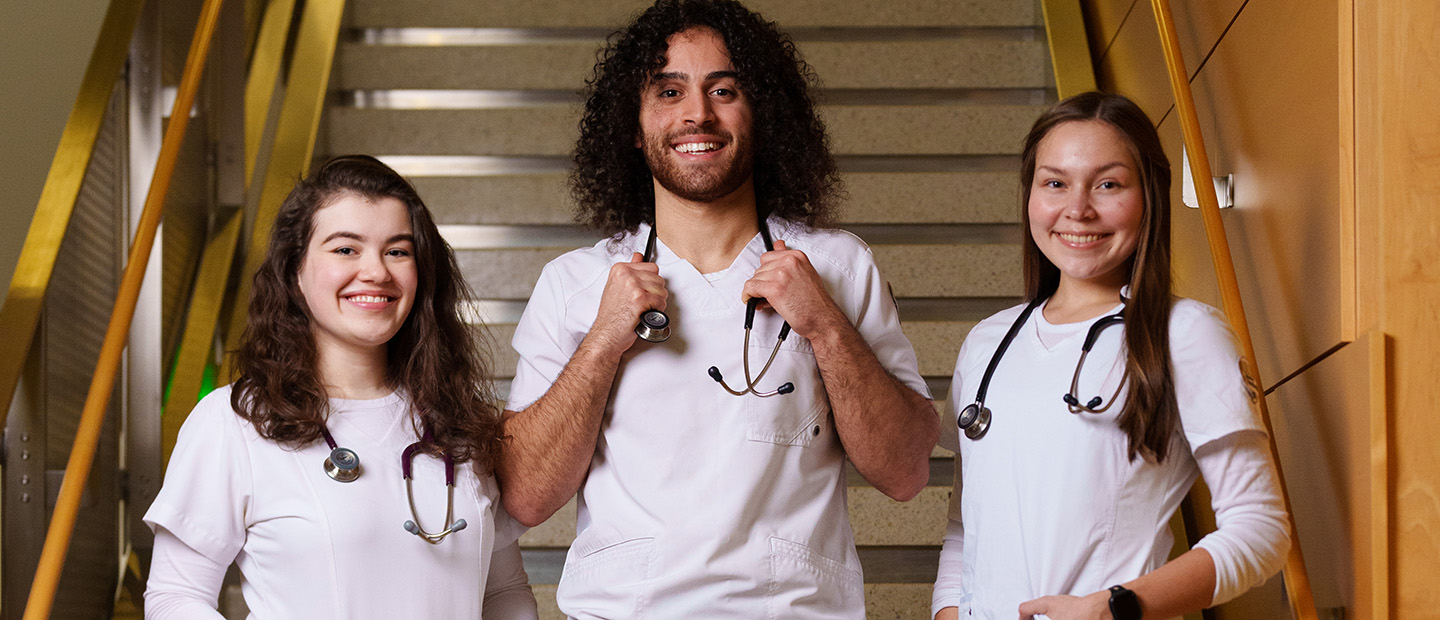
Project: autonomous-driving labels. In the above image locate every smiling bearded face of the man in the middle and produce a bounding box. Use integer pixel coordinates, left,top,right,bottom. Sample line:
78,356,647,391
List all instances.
636,27,753,203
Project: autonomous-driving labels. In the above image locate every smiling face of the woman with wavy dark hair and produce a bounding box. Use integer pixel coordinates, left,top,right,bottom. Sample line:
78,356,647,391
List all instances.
297,193,418,358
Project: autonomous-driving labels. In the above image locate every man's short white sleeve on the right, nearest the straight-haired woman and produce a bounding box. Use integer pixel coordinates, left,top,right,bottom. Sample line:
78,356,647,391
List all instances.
851,239,930,398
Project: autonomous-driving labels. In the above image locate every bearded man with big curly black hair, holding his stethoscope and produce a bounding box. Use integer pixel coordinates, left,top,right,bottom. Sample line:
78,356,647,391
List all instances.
498,0,939,619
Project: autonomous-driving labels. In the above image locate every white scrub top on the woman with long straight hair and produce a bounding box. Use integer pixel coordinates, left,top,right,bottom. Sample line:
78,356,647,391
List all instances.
933,299,1287,619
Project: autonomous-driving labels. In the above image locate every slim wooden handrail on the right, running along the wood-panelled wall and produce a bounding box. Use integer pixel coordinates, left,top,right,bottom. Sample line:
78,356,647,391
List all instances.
1151,0,1319,620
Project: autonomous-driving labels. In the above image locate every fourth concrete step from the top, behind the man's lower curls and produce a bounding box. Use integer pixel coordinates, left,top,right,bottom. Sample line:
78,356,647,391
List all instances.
406,169,1020,226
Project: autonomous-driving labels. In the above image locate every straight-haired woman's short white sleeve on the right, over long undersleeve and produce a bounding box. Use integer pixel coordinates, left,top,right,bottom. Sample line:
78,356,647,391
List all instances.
1171,299,1264,450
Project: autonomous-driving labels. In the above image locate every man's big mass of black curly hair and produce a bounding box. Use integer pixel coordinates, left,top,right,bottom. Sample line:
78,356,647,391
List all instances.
570,0,840,236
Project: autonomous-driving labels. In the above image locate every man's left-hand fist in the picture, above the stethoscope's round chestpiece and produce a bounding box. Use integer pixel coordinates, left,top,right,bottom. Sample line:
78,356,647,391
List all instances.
586,252,670,355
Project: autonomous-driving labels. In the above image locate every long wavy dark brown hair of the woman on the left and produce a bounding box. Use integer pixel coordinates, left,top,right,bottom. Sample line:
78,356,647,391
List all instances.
230,155,503,470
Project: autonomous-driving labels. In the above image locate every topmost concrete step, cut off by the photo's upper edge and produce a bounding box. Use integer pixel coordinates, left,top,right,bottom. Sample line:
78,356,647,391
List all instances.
348,0,1041,29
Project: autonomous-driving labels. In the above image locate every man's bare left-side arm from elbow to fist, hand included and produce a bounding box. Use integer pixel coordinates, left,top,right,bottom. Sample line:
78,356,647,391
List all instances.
497,253,668,526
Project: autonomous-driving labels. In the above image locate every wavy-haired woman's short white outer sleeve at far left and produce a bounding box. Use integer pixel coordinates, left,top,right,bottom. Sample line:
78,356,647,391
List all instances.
144,390,253,567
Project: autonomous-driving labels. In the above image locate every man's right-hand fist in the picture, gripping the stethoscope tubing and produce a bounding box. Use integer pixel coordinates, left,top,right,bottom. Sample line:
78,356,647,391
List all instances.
740,240,850,338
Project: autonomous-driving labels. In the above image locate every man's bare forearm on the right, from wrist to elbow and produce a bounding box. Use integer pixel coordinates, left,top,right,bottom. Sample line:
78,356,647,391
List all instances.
811,321,940,501
